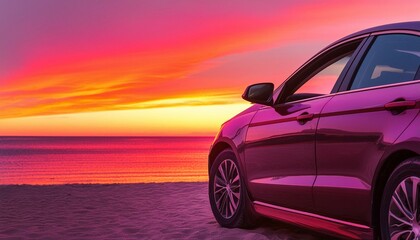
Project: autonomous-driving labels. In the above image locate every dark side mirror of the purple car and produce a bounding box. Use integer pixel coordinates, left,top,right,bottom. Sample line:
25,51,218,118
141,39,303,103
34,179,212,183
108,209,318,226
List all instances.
242,83,274,106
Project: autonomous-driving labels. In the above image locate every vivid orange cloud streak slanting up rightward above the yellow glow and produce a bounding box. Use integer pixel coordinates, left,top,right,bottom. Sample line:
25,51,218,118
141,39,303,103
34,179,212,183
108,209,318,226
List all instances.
0,2,298,118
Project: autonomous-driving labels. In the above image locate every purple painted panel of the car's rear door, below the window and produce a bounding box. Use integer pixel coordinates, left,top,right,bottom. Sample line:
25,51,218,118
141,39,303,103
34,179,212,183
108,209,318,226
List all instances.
313,82,420,225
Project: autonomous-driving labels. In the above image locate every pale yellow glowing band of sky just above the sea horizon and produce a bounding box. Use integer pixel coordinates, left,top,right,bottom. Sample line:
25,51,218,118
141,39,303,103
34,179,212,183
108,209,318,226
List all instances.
0,103,250,136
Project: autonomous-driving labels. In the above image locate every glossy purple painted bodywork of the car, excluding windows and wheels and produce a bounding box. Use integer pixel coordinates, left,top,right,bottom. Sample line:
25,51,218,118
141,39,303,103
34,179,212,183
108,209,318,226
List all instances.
209,22,420,239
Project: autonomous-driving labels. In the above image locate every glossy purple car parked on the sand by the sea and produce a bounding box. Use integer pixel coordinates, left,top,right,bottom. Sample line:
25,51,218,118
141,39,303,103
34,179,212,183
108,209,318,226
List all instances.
209,22,420,240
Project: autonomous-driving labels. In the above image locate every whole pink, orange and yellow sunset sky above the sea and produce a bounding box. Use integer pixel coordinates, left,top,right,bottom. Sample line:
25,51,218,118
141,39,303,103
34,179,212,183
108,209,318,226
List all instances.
0,0,420,136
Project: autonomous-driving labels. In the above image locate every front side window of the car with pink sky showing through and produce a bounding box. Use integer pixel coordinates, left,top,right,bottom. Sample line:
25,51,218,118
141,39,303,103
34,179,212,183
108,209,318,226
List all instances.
295,54,351,94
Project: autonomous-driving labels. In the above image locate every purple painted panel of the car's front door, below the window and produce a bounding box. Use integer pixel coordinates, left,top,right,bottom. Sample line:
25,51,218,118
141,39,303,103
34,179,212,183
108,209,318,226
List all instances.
245,97,331,211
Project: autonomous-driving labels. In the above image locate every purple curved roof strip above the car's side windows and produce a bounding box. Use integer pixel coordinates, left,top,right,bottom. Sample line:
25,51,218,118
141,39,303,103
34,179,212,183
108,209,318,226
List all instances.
326,21,420,48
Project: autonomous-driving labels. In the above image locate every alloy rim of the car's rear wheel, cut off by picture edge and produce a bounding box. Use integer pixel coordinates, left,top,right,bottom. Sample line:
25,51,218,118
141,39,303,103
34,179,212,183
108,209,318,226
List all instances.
388,177,420,240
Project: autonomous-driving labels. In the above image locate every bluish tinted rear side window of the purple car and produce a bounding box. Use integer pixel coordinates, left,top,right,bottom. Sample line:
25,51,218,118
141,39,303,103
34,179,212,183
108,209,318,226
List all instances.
350,34,420,90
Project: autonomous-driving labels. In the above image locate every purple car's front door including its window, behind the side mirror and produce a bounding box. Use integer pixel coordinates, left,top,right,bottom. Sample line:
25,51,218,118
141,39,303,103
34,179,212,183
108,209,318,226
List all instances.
244,39,362,211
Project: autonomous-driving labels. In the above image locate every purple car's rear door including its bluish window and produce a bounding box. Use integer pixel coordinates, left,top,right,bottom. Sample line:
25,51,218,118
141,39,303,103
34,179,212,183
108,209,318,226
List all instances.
313,33,420,225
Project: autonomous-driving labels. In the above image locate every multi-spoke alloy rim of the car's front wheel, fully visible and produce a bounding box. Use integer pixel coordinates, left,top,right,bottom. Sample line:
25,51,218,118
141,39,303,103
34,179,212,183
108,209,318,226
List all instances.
213,159,241,219
